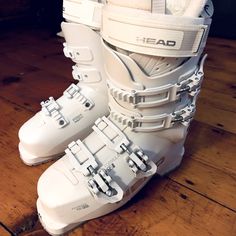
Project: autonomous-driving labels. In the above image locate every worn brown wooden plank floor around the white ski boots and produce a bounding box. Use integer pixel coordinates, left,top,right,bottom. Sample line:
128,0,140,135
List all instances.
0,26,236,236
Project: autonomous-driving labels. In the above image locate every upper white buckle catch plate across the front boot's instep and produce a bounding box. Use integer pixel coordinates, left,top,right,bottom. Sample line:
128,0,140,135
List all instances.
92,117,130,153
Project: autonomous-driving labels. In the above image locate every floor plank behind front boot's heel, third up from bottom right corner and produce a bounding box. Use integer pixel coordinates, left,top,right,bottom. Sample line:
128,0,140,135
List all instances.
185,121,236,175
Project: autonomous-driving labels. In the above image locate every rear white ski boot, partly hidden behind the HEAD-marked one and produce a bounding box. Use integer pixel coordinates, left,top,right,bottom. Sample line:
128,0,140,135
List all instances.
19,0,108,165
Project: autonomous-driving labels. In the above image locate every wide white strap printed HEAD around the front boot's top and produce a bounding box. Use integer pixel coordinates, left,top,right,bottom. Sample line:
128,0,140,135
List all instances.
102,5,211,57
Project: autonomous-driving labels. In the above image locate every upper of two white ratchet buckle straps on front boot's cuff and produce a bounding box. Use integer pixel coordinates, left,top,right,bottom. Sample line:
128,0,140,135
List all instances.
107,56,206,108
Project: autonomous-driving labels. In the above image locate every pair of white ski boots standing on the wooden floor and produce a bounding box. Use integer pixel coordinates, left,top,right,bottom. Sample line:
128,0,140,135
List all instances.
19,0,213,235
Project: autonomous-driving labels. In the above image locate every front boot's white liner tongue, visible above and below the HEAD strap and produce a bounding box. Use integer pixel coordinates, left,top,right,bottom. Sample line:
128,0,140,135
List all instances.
111,0,206,76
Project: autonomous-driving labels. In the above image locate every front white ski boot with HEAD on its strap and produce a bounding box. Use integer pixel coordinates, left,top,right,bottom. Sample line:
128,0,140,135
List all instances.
37,0,214,235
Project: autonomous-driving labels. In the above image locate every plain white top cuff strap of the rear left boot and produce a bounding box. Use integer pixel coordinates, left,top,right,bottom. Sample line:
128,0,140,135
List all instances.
63,0,103,30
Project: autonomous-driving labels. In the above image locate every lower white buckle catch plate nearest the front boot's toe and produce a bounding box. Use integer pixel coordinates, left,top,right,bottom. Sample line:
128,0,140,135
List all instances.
65,140,98,176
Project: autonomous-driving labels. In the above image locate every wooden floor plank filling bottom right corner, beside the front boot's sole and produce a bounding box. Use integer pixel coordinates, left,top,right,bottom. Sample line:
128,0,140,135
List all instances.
69,177,236,236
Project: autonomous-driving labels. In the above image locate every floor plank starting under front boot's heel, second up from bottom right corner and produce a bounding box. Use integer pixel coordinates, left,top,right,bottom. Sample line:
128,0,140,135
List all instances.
170,157,236,211
